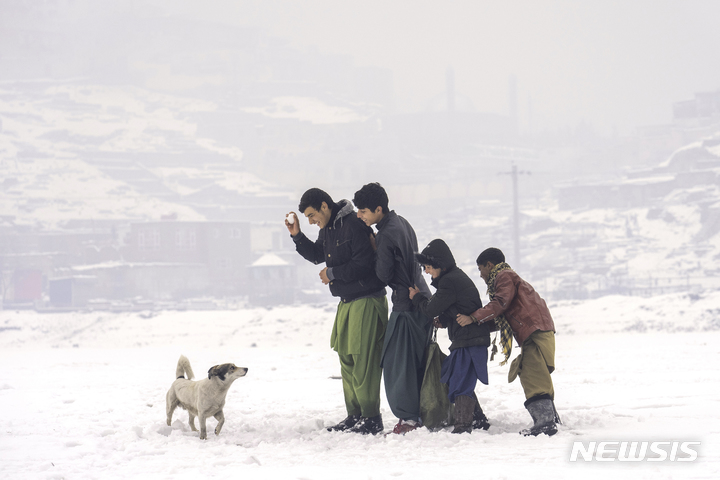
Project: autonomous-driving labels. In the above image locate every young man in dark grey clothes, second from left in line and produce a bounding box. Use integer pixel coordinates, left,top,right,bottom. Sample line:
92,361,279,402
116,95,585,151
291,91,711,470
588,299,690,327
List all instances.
353,183,432,434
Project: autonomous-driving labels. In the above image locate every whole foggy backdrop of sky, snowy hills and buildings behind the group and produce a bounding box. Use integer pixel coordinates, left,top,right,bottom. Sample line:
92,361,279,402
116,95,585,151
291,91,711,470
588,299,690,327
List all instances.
0,0,720,309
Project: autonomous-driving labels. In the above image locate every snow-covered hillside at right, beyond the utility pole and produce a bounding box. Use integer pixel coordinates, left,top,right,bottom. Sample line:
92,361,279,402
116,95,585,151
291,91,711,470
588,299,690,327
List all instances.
442,135,720,300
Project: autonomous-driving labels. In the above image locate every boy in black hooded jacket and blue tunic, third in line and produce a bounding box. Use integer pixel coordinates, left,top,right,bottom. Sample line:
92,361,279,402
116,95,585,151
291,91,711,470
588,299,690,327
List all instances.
410,239,490,433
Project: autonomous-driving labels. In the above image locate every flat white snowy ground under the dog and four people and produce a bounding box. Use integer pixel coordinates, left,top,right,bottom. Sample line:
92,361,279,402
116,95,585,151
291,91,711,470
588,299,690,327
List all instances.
0,294,720,479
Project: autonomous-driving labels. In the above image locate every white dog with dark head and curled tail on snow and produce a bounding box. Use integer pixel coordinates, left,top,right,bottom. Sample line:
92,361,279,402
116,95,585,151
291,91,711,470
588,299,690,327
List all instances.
166,355,248,440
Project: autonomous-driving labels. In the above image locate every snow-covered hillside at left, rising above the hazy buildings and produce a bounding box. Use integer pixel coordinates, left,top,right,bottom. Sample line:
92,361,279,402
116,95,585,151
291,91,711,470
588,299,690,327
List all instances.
0,81,272,228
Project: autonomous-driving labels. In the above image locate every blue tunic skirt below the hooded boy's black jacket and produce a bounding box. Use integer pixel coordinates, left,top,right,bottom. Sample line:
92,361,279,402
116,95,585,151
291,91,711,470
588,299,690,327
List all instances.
440,346,488,403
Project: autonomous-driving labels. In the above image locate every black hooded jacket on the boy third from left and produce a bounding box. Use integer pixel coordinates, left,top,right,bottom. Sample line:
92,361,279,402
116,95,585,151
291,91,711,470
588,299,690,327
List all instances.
413,239,490,350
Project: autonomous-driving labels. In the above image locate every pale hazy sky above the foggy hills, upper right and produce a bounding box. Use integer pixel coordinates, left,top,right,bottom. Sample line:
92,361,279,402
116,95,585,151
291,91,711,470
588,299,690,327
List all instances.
165,0,720,133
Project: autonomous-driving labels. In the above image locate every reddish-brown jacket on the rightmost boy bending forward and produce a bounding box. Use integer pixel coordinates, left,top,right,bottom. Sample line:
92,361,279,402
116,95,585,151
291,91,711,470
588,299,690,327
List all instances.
471,270,555,345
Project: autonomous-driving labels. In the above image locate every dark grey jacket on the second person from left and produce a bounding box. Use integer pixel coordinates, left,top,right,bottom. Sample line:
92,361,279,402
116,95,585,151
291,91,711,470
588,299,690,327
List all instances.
375,210,431,312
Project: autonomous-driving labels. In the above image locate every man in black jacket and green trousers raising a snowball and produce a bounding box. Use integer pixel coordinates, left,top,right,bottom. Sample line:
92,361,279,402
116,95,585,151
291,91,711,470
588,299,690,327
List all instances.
285,188,388,435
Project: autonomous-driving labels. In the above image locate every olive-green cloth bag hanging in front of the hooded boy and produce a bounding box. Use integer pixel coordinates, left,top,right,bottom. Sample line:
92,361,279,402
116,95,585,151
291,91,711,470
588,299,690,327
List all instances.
420,328,450,430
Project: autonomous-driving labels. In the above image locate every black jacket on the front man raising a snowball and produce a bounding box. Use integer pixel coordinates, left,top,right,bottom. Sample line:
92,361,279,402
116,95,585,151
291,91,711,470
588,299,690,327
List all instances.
293,200,385,302
